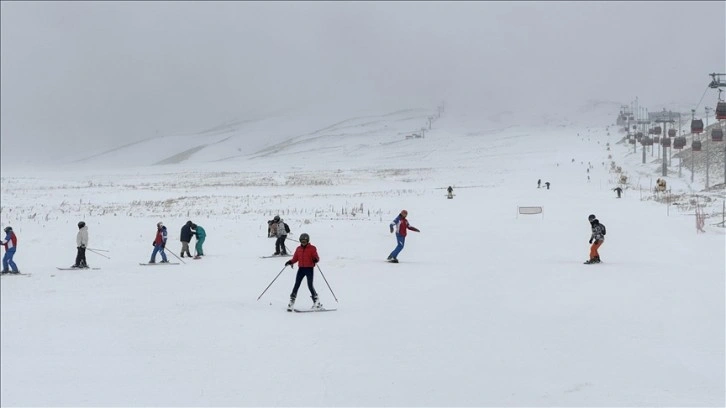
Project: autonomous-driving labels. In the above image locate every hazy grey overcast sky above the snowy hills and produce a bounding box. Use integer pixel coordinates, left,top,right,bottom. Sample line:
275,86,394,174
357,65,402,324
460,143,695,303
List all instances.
0,1,726,164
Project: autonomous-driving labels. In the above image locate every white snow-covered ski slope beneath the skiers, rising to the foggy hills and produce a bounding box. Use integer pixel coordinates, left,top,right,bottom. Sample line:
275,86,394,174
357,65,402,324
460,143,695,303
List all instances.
0,104,726,406
